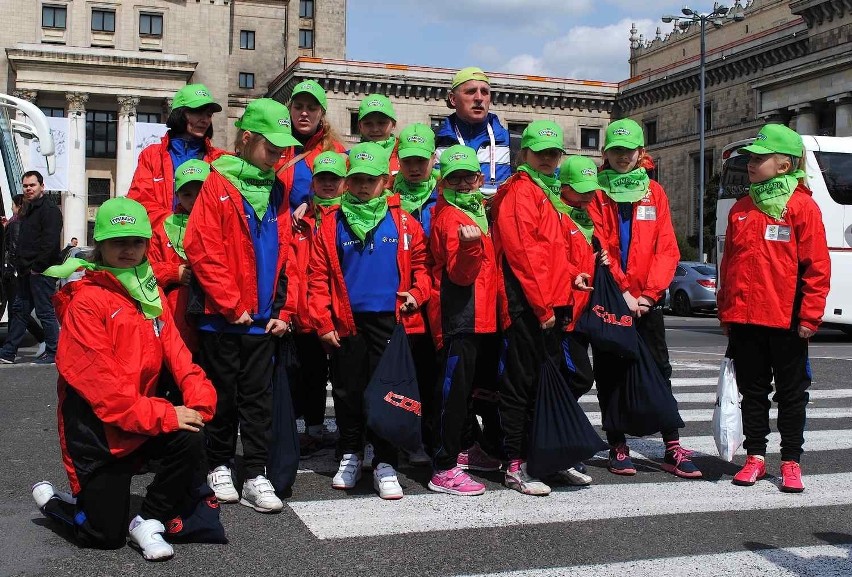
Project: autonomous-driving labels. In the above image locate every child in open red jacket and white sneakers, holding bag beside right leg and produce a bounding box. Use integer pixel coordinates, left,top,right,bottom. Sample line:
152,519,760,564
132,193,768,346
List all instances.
308,142,430,499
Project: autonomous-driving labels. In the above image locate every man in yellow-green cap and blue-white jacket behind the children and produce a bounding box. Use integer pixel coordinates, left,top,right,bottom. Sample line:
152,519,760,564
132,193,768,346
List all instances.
435,67,512,196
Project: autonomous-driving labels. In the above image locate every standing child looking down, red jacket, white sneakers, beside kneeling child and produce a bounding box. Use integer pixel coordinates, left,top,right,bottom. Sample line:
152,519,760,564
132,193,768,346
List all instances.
184,98,298,513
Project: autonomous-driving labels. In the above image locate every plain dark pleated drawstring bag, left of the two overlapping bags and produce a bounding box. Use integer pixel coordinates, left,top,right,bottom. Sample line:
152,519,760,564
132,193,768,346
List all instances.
527,358,609,479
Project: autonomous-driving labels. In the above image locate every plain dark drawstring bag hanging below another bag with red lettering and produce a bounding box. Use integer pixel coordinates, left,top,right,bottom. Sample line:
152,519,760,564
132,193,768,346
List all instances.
602,334,684,437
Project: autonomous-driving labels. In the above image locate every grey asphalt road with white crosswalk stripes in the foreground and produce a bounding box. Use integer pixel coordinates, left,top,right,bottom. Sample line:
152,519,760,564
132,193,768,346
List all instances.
0,317,852,577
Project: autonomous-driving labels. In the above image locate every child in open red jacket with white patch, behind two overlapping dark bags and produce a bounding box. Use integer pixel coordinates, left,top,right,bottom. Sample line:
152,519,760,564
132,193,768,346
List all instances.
589,118,701,479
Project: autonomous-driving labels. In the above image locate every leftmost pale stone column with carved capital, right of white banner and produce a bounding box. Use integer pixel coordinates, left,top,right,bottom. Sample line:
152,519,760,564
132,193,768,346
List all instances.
62,92,89,246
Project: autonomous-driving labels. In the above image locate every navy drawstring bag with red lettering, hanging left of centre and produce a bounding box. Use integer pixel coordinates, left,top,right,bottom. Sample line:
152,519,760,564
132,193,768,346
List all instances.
364,324,422,452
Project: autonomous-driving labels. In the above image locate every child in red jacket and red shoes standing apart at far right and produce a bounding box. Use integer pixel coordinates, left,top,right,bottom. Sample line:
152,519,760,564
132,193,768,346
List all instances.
718,124,831,493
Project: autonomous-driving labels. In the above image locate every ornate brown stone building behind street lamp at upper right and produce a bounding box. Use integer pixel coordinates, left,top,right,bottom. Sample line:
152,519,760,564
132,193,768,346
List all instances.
614,0,852,246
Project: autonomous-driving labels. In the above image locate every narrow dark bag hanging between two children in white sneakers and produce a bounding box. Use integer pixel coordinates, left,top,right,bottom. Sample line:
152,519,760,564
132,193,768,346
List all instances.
266,337,299,495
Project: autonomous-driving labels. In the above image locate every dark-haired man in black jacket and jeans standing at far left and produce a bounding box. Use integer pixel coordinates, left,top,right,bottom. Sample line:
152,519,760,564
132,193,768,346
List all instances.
0,170,62,364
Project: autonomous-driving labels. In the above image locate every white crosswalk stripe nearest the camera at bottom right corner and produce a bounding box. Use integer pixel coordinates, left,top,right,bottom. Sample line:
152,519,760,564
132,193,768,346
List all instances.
459,545,852,577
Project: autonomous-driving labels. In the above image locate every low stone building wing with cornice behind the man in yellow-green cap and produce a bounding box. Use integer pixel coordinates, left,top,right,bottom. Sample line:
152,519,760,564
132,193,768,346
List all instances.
269,57,618,157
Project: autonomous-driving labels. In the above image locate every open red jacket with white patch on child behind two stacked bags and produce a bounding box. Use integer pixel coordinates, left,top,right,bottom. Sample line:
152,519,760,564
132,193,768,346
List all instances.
589,180,680,303
